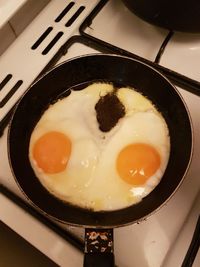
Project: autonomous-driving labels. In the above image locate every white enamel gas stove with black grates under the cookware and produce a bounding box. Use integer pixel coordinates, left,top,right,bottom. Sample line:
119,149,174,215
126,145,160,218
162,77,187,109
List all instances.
0,0,200,267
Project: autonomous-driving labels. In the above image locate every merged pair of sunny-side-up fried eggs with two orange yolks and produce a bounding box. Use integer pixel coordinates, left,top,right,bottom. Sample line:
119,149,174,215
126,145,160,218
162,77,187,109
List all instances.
29,83,170,211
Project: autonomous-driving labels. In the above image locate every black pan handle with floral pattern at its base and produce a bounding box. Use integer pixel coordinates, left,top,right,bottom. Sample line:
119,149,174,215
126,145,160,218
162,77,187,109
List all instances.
83,228,115,267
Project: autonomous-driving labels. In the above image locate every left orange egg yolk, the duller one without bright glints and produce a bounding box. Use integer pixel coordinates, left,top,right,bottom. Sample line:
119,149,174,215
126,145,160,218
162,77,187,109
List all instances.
33,131,71,174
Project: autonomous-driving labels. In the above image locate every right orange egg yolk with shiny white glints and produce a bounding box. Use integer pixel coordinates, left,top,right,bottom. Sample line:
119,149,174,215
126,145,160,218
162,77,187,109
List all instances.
116,143,160,186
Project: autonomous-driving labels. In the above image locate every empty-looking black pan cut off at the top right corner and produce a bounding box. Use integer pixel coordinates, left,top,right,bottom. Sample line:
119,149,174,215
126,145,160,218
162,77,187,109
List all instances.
123,0,200,33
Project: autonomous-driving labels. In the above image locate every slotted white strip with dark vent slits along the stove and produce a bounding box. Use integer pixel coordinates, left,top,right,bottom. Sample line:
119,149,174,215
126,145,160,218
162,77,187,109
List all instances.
0,0,99,121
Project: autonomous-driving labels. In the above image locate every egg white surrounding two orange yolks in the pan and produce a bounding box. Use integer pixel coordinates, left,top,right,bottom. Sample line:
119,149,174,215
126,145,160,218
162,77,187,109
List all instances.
29,83,170,213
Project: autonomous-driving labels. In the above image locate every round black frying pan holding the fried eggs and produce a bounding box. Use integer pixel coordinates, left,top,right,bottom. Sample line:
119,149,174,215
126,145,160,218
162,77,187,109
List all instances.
8,54,192,266
